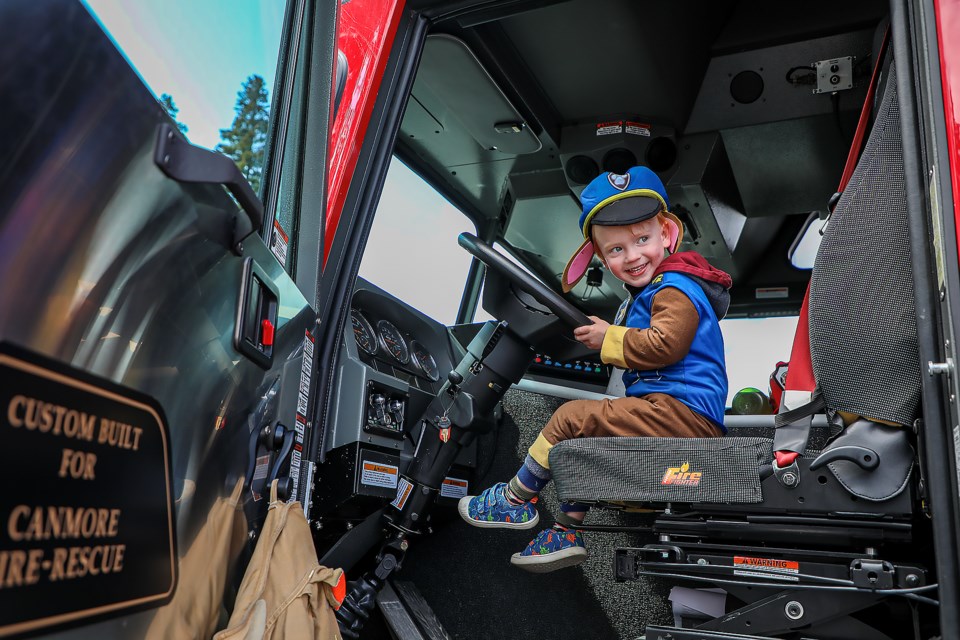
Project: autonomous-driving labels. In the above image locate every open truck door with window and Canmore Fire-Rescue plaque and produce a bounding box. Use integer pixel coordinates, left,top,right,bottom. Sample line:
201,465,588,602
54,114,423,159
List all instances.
0,0,340,638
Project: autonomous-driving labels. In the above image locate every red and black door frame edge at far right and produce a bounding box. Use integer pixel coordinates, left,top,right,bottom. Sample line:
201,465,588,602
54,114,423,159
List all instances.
891,1,960,637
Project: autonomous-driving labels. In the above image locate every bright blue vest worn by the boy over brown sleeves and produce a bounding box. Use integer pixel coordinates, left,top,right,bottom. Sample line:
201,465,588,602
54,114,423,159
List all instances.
616,271,727,433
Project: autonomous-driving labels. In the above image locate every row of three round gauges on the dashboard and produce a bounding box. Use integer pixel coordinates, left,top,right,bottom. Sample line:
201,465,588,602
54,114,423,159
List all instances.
350,301,446,383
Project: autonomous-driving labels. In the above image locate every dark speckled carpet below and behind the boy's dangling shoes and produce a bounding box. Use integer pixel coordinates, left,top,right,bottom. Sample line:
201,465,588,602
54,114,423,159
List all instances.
398,390,673,640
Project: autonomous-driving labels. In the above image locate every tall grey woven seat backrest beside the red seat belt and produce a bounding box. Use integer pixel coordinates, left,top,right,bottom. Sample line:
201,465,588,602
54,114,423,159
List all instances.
810,65,920,425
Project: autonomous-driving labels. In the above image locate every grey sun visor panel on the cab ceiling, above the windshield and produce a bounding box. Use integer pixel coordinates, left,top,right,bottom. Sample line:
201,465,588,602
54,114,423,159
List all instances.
411,34,542,155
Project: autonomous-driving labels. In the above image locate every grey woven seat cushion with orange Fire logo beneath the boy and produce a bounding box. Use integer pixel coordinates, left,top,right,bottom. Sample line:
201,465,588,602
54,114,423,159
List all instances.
550,437,773,504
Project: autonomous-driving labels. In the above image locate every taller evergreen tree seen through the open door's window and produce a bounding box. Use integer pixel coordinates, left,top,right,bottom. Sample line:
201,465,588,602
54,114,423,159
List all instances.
217,75,270,193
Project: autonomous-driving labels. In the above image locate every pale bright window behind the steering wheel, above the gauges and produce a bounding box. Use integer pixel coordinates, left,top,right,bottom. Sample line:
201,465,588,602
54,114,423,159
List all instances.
360,157,475,325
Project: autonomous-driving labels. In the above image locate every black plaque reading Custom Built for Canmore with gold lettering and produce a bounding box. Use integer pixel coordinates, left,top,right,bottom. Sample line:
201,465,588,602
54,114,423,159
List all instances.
0,344,177,637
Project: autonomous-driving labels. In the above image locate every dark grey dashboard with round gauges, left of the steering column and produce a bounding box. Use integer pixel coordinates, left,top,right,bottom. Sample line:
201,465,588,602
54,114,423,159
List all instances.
312,278,476,519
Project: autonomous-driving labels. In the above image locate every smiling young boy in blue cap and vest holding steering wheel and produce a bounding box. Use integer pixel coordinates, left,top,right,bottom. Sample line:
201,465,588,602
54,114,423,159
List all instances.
459,167,731,573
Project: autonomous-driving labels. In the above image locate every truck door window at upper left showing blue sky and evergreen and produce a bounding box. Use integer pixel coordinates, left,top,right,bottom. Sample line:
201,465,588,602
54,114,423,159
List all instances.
85,0,285,195
